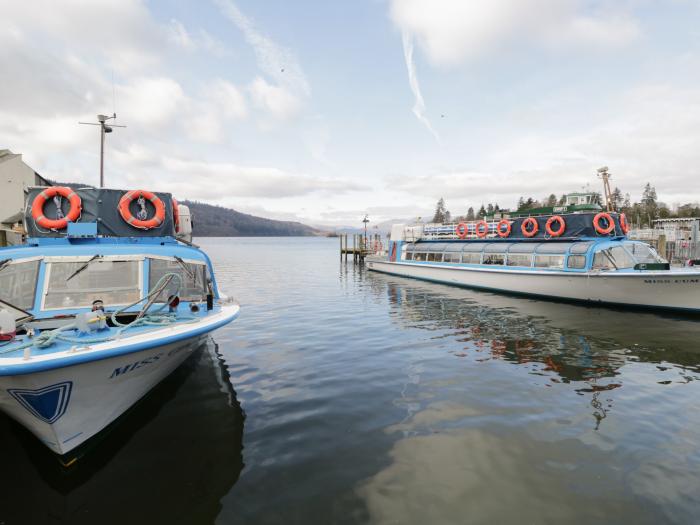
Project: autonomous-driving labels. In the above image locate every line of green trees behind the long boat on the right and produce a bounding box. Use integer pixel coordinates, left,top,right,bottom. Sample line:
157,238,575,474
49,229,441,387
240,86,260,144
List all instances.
432,182,700,227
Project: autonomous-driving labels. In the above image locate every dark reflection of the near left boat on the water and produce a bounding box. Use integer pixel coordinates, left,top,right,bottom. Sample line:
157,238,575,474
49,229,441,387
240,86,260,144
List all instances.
0,340,244,524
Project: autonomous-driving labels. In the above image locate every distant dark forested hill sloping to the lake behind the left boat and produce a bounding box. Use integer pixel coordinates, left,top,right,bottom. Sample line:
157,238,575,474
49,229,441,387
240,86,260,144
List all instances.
181,201,324,237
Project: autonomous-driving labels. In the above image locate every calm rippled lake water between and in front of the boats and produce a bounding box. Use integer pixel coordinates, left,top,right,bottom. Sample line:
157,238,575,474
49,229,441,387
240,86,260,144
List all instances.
0,238,700,524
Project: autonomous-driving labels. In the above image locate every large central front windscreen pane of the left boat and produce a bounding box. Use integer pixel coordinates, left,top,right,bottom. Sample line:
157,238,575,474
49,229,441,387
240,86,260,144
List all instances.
44,259,141,309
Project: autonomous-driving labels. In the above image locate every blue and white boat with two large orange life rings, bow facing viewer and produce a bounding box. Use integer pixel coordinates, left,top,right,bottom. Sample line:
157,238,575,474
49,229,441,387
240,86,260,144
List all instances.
0,188,239,454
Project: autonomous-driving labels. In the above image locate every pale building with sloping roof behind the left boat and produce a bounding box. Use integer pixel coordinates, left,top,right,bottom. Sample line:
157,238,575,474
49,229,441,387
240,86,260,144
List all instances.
0,149,51,246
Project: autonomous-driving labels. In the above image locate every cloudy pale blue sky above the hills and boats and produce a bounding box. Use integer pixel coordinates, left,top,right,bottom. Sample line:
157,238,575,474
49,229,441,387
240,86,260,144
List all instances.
0,0,700,225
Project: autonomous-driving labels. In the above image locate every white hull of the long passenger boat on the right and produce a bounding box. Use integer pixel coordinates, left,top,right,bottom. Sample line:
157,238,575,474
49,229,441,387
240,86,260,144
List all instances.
366,257,700,312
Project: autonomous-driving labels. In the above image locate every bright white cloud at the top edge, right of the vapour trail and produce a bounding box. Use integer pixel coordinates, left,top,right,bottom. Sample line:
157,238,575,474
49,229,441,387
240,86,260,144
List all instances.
391,0,639,66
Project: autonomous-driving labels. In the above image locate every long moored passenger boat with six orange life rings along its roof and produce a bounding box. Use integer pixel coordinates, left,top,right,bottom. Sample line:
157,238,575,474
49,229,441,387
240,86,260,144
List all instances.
366,212,700,312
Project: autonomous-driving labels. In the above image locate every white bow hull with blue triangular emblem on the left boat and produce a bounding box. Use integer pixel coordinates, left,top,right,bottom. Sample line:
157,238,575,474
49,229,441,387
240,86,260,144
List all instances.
0,305,239,455
